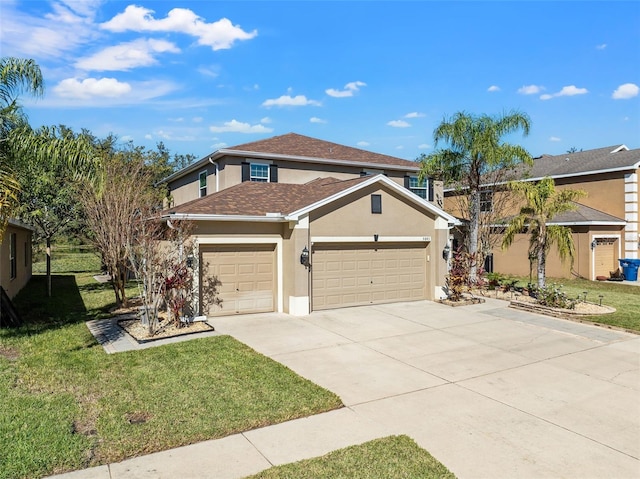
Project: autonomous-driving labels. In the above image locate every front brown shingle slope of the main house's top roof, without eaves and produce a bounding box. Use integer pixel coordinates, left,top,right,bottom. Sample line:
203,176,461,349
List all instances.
225,133,419,168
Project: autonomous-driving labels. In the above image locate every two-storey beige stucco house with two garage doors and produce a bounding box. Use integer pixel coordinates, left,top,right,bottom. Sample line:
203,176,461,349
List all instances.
163,133,456,315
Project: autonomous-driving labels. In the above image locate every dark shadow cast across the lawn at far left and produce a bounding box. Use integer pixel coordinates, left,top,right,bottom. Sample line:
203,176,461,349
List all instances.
3,275,114,337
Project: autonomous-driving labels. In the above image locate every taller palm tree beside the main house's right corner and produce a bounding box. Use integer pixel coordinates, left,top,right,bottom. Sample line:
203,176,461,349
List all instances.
419,111,532,281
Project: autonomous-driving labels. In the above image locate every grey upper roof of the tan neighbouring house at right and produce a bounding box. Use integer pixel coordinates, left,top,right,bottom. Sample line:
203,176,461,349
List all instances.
527,145,640,180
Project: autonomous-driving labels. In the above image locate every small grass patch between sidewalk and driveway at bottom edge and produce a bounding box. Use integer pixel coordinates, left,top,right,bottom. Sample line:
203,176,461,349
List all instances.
245,436,455,479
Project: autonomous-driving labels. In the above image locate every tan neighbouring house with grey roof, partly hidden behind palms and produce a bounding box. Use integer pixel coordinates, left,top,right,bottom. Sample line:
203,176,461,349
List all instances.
445,145,640,280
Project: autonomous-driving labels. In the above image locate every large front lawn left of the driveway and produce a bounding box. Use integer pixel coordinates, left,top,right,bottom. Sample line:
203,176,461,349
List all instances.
0,253,341,479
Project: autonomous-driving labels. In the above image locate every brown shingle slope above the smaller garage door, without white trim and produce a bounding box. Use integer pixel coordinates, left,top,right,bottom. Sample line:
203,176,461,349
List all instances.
164,177,367,216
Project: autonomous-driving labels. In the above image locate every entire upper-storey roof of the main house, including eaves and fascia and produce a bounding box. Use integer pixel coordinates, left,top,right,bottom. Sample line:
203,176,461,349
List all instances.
162,133,420,182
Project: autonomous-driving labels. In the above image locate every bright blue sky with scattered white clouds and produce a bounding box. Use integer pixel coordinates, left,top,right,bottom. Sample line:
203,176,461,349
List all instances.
0,0,640,160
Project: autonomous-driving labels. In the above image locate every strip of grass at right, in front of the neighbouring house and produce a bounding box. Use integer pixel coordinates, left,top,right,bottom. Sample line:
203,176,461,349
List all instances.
504,278,640,333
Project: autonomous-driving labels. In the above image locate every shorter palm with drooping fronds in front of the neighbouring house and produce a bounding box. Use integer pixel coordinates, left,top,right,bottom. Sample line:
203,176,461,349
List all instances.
502,178,586,288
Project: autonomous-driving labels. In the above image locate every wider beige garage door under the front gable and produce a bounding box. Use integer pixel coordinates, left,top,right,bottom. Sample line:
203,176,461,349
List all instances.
311,244,426,310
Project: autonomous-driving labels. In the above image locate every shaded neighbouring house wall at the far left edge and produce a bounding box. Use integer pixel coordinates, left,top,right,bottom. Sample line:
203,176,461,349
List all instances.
0,219,33,298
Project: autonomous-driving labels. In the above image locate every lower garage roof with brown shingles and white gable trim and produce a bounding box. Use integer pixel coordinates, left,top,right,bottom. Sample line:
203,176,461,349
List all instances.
162,175,457,223
